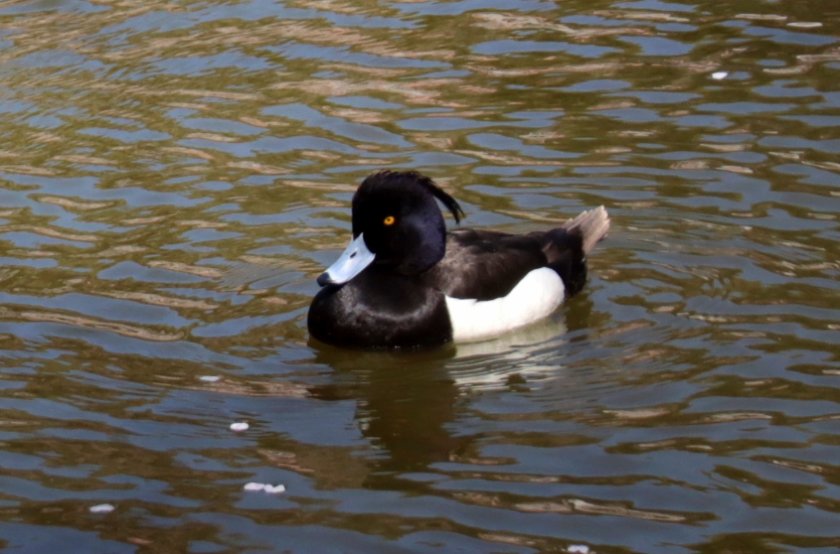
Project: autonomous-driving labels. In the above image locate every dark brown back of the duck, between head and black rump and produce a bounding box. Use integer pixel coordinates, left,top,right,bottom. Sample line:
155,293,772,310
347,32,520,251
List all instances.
423,229,548,300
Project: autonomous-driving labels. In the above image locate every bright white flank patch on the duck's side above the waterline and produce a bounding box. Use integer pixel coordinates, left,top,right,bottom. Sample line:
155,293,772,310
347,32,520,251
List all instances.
446,267,566,341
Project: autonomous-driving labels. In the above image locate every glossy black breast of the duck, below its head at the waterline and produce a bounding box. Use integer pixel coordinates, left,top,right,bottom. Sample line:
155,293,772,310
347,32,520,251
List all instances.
307,266,452,348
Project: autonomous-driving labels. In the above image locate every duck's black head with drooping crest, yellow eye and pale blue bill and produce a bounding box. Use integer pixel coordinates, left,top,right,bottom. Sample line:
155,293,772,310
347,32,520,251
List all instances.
318,171,464,285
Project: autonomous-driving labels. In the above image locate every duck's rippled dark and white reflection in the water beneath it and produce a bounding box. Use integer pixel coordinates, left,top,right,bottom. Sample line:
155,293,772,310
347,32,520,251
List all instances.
310,312,576,477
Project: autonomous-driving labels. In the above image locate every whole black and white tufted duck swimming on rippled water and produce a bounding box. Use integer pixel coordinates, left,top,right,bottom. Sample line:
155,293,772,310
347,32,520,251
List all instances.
307,171,609,349
